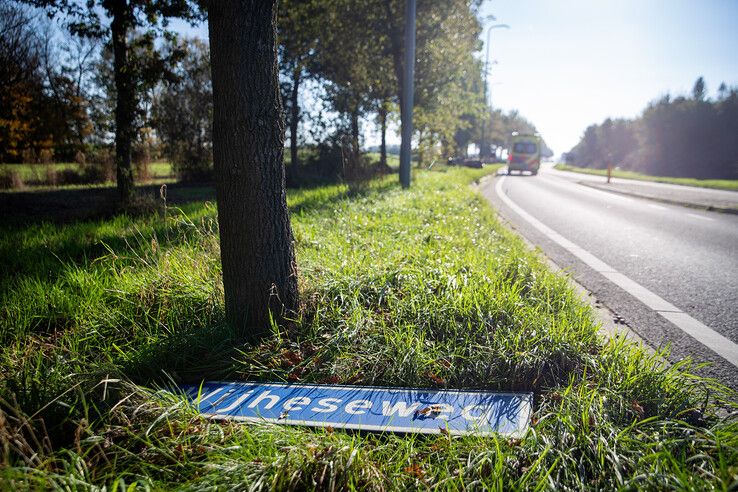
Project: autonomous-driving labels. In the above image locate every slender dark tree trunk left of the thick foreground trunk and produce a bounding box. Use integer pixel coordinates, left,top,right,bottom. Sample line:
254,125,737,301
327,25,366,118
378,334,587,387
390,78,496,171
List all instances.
110,0,136,206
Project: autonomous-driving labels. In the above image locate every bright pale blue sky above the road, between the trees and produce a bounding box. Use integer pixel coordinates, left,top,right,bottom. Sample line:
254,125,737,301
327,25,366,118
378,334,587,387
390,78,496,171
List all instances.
481,0,738,154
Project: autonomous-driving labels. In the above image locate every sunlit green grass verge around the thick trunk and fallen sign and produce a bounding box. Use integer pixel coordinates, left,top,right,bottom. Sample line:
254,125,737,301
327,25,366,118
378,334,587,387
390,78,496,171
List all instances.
0,168,738,490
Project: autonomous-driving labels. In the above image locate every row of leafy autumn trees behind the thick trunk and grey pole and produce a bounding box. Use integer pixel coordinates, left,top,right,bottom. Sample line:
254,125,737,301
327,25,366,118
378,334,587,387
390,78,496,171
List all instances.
0,0,548,201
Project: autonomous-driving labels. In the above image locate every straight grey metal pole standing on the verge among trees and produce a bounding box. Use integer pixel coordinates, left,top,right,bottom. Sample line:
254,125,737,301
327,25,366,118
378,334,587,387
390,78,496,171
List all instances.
400,0,415,188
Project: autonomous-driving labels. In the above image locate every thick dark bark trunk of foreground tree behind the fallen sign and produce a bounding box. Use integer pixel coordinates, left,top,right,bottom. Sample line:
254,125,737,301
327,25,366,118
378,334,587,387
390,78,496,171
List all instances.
208,0,298,340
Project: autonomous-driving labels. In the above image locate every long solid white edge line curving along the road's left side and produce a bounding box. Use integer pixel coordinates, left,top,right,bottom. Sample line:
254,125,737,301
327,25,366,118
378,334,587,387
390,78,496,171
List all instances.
495,176,738,367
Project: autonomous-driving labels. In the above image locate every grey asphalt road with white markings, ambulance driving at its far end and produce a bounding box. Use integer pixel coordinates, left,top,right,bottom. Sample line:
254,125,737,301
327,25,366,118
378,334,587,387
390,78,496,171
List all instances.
482,169,738,388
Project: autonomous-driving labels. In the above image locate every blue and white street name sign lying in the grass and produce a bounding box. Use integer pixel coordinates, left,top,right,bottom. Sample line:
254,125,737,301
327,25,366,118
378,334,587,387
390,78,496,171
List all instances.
183,382,533,436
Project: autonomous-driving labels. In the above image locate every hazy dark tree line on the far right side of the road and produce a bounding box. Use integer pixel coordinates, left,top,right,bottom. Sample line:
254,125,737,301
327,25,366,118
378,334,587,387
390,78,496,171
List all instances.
566,77,738,179
